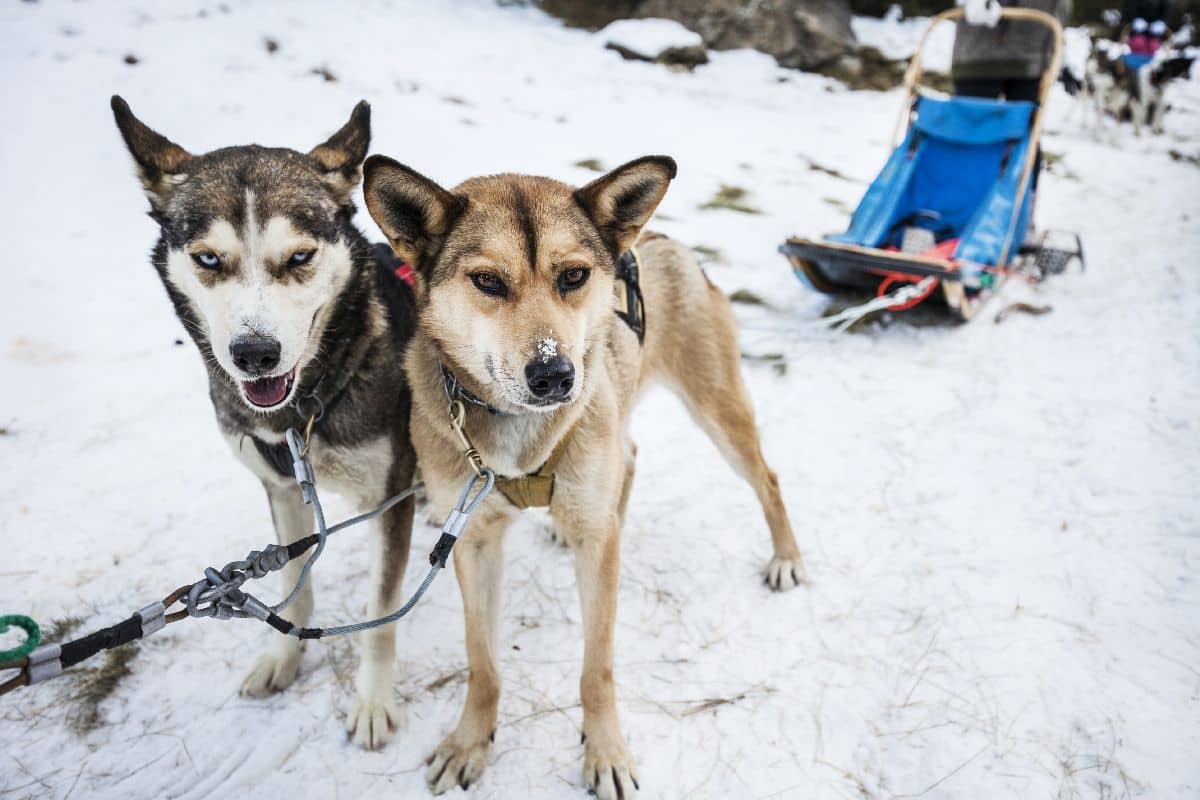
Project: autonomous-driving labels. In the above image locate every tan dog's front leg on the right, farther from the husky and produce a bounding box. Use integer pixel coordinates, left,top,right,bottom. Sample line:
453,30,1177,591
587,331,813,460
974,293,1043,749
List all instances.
559,510,638,800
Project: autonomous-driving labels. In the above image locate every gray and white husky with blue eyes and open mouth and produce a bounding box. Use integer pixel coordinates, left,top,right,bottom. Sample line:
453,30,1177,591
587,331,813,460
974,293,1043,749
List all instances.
113,97,415,748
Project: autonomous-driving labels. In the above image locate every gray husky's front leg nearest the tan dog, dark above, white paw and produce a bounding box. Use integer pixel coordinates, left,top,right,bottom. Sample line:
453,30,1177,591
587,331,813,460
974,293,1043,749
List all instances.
346,494,413,750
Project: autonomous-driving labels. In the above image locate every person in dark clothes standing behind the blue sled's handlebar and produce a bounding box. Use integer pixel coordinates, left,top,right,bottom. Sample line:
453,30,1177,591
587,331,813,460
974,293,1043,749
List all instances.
950,0,1072,240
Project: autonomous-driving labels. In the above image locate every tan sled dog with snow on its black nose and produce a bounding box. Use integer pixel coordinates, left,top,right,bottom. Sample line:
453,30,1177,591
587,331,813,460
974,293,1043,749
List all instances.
364,156,804,799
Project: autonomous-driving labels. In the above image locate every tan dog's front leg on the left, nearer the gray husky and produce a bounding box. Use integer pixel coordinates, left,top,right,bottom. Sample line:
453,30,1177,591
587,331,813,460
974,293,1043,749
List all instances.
425,505,511,794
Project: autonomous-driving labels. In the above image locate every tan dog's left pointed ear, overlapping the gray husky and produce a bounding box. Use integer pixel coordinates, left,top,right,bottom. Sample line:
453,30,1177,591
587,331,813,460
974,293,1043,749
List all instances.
362,156,467,270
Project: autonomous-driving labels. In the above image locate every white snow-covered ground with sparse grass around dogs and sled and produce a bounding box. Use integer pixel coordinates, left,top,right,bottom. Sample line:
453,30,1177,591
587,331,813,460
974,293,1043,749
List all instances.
0,0,1200,799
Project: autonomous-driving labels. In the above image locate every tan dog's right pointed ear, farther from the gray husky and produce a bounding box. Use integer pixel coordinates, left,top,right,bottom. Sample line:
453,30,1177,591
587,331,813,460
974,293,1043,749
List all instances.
575,156,676,253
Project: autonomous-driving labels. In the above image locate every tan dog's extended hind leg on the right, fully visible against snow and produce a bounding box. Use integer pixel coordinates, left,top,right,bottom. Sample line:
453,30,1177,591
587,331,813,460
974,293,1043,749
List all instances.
670,297,805,591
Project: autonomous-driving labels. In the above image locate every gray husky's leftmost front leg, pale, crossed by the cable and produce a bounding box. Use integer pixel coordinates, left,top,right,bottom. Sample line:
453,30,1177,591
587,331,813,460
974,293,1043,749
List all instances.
241,482,313,697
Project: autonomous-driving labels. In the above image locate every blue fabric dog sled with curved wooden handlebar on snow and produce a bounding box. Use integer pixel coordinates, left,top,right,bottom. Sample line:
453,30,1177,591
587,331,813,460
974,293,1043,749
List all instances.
780,8,1084,320
